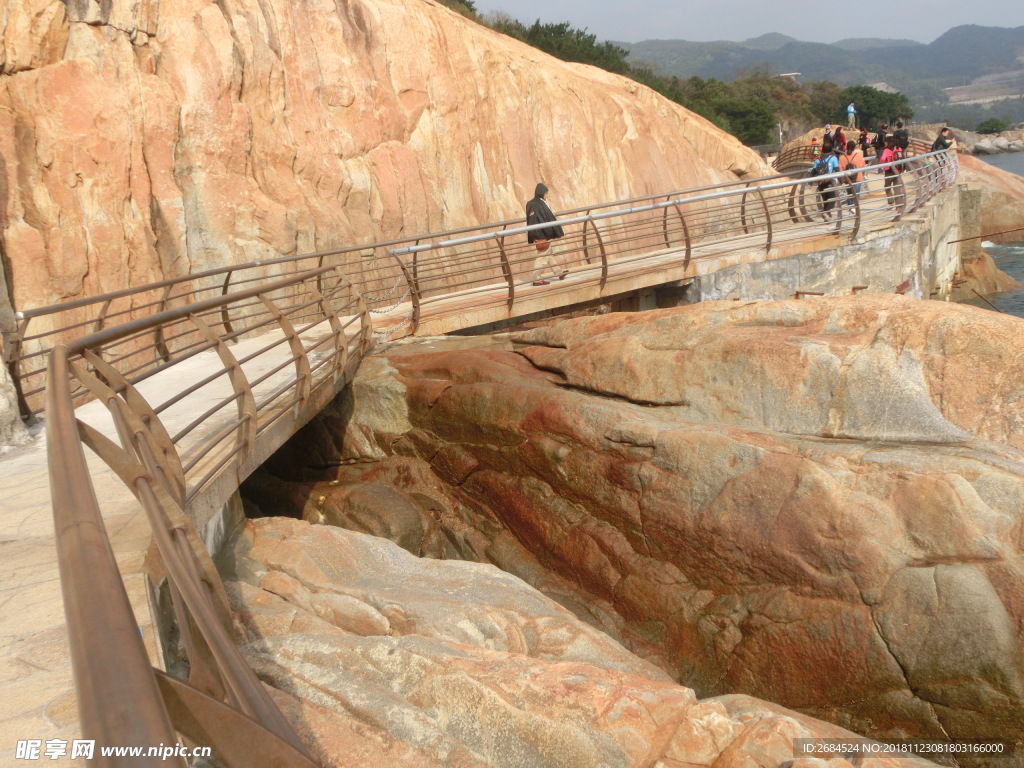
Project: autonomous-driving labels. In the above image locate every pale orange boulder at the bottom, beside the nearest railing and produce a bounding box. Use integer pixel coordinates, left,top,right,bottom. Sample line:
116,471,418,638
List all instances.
228,518,930,768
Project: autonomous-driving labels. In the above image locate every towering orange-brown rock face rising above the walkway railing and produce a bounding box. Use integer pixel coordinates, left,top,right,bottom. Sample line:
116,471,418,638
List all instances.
0,0,764,309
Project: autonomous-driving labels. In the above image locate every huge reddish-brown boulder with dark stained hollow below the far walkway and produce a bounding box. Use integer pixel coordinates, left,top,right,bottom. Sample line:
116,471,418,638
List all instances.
258,296,1024,753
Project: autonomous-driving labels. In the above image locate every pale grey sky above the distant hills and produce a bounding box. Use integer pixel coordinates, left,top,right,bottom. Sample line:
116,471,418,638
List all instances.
473,0,1024,43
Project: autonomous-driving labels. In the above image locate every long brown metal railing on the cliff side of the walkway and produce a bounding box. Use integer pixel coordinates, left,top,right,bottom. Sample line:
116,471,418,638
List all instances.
5,150,955,416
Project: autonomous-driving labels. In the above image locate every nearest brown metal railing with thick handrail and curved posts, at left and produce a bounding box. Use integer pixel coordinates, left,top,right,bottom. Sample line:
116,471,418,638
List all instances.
46,267,371,768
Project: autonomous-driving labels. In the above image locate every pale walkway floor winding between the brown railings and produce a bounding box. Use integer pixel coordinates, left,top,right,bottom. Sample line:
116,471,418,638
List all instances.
0,176,955,766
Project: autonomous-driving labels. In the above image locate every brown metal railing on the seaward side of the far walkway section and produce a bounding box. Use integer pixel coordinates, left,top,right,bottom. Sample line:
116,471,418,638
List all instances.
378,152,956,333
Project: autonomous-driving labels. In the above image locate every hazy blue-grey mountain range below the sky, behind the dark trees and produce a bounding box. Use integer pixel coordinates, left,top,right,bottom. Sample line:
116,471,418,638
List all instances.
616,25,1024,91
